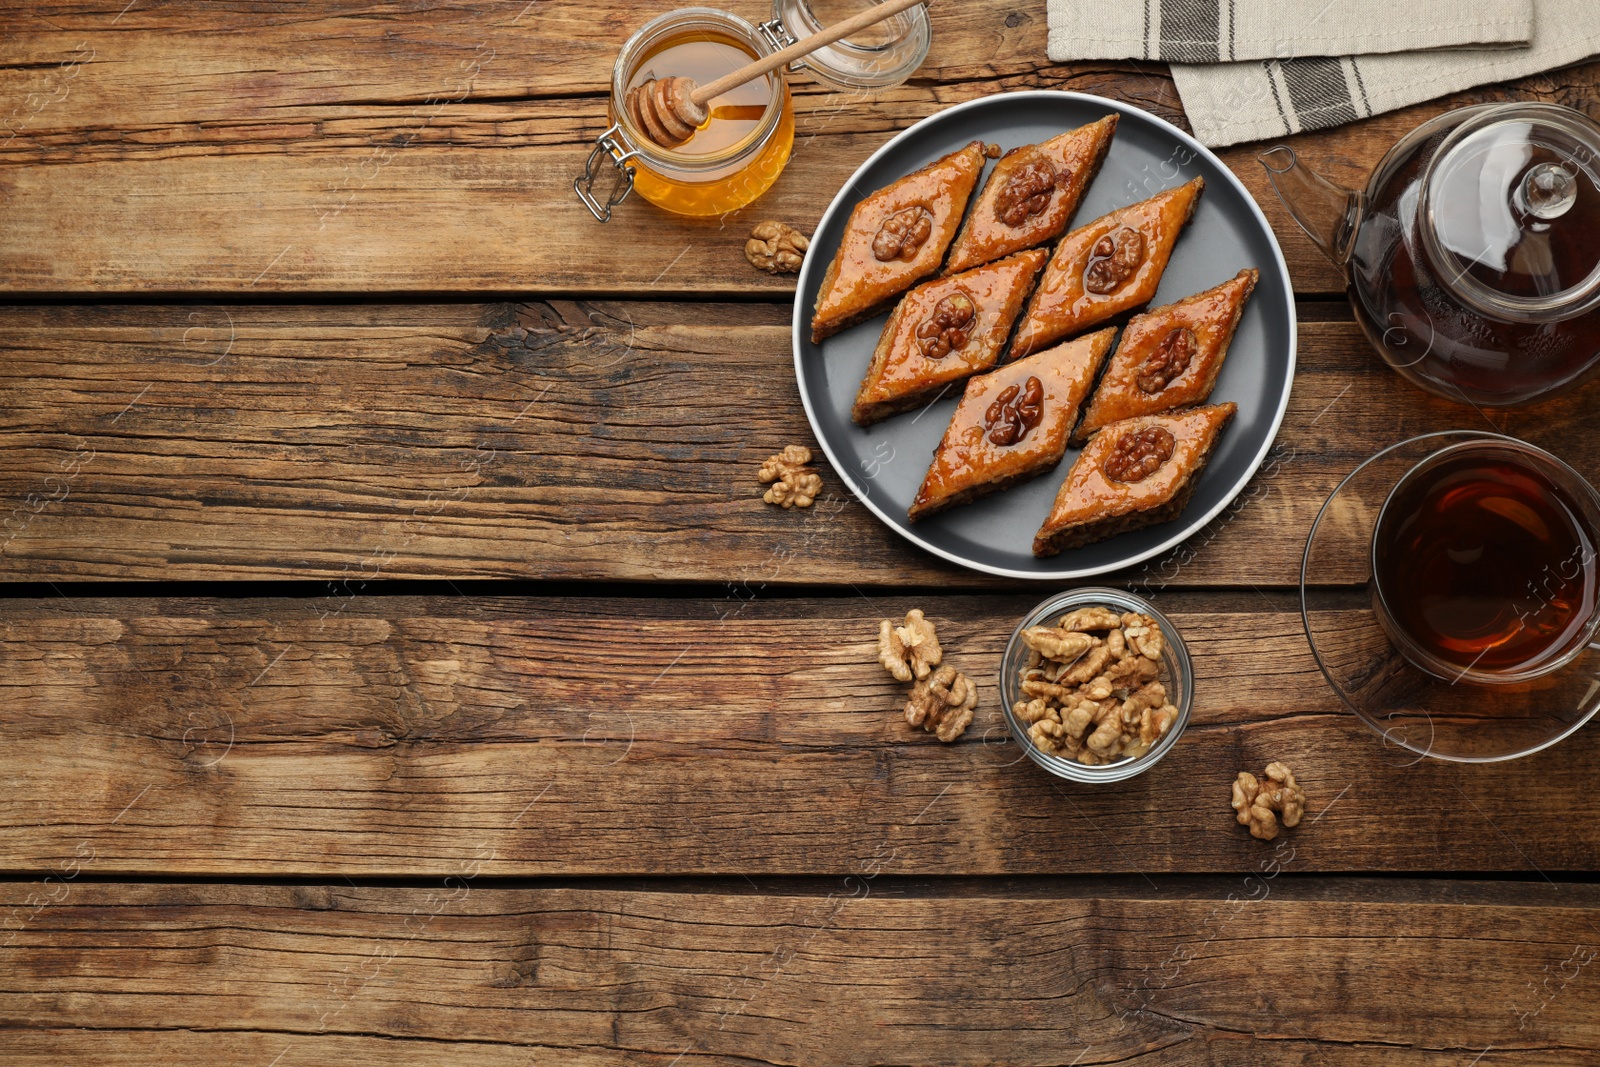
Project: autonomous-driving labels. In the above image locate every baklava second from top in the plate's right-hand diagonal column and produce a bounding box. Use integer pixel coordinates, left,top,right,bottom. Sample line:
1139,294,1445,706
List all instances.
1011,178,1205,358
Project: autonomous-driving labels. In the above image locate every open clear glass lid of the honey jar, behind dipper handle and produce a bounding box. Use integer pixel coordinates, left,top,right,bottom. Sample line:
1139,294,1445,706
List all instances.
762,0,933,91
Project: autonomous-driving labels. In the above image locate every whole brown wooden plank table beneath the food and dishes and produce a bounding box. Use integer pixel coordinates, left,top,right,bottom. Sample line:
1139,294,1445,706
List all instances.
0,0,1600,1067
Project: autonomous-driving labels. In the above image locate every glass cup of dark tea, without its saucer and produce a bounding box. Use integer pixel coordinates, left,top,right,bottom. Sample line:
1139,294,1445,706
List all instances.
1370,440,1600,686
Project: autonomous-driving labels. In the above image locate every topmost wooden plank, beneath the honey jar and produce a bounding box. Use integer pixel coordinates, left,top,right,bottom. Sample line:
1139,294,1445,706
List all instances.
0,0,1600,296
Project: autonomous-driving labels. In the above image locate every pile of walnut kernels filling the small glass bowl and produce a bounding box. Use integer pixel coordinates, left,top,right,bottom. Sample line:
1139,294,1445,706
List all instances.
1011,606,1178,766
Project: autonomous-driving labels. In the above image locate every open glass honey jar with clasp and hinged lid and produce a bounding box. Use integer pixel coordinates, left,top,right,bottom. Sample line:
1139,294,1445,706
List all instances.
573,0,931,222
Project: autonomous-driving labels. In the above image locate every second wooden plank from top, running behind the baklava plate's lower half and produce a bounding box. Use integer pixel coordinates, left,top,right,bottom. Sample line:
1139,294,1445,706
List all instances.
0,302,1600,589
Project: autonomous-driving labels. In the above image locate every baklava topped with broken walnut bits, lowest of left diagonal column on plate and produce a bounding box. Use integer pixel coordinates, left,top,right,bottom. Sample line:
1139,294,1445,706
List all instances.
910,330,1117,522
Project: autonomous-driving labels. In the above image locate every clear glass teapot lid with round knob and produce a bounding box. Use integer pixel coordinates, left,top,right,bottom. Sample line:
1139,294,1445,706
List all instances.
1421,104,1600,322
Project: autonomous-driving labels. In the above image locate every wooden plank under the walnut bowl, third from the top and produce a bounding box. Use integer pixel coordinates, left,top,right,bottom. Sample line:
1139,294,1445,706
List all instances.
0,593,1600,877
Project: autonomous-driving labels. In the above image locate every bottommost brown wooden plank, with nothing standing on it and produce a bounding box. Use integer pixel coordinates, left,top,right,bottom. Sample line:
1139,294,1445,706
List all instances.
0,872,1600,1067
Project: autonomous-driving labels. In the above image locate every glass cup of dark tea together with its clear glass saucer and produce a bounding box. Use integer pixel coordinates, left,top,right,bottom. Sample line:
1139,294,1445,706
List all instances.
1301,430,1600,766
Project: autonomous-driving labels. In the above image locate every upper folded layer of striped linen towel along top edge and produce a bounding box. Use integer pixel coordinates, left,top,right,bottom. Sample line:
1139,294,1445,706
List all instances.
1048,0,1533,62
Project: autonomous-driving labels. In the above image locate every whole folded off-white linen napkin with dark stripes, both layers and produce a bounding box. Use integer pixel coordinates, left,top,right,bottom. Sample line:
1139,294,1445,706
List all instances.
1048,0,1600,146
